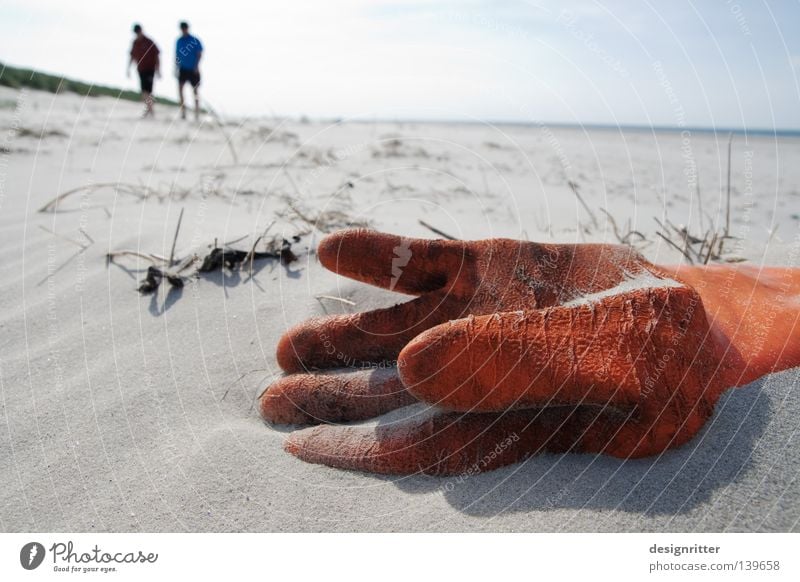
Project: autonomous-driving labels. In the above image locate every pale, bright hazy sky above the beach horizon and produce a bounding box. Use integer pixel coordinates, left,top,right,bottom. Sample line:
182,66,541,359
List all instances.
0,0,800,130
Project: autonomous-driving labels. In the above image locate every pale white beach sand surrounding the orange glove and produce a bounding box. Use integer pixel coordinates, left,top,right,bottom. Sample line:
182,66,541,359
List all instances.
0,89,800,531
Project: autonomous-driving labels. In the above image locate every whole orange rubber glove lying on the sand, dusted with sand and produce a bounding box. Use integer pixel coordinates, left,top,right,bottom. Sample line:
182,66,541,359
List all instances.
260,230,800,475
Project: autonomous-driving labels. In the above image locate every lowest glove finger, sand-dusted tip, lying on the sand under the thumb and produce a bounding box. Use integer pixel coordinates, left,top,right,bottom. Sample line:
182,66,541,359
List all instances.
284,407,624,475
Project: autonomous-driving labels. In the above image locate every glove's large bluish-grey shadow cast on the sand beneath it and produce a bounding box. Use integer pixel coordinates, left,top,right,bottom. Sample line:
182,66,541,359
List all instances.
382,378,778,517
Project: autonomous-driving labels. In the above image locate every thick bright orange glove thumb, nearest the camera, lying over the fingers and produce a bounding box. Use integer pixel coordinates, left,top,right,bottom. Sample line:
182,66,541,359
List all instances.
398,286,708,412
